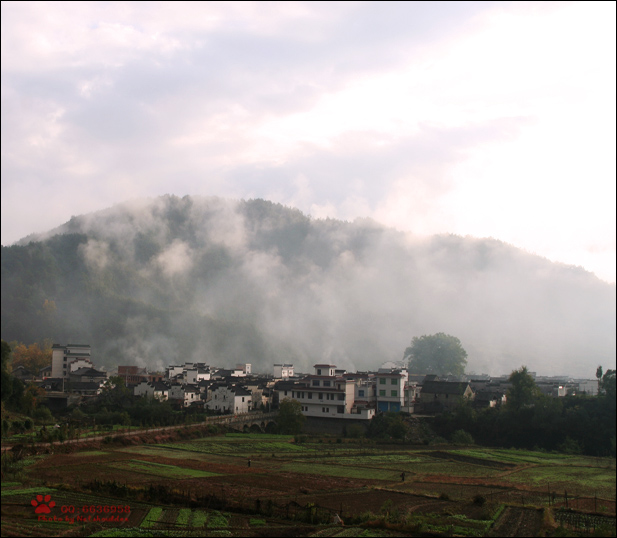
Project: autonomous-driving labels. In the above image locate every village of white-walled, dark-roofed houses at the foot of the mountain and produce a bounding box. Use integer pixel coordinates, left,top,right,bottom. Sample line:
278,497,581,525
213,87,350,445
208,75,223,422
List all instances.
13,344,598,421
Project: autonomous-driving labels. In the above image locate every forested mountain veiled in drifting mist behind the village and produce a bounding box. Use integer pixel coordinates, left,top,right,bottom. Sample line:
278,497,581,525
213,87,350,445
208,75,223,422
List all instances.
1,195,615,378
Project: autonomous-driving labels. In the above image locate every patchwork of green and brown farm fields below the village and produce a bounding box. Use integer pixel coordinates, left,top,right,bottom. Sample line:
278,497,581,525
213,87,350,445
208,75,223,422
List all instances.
2,434,615,536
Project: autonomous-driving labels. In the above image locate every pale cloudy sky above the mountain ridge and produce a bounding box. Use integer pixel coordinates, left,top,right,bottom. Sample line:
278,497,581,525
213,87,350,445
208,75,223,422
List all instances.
1,1,617,283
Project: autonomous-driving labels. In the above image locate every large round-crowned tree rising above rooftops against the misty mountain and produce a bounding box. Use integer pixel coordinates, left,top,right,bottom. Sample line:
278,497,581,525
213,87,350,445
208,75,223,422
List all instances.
403,333,467,375
